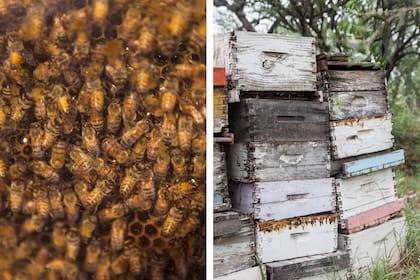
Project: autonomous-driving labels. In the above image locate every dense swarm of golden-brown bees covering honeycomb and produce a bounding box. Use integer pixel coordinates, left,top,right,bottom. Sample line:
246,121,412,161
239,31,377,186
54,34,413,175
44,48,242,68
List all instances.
0,0,206,280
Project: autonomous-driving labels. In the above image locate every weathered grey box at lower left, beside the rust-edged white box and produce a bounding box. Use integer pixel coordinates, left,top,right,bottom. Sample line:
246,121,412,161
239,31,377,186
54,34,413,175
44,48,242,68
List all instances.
213,215,255,277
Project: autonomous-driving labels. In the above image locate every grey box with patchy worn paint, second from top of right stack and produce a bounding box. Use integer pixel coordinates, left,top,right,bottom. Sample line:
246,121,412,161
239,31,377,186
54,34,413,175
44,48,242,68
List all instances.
328,90,388,121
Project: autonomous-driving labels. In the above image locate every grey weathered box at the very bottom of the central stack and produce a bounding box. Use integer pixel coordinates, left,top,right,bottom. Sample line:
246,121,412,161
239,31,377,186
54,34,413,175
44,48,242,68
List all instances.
266,250,350,280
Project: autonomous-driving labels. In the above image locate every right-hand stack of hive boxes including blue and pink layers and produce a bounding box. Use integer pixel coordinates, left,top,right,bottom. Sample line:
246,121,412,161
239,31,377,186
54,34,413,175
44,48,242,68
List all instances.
318,54,406,275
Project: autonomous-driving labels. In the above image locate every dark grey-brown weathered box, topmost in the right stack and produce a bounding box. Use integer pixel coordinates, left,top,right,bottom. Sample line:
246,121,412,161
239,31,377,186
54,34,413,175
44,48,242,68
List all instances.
328,70,385,92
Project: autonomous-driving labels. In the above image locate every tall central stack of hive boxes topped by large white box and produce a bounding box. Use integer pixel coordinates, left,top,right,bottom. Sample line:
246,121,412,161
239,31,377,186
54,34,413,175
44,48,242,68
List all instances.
215,32,348,279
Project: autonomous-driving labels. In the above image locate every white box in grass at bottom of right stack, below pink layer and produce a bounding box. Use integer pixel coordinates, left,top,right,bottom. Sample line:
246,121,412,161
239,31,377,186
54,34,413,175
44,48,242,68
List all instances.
338,217,407,276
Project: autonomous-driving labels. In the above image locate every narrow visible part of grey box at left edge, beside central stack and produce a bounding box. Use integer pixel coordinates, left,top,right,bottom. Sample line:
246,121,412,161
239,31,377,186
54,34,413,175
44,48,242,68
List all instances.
213,143,231,211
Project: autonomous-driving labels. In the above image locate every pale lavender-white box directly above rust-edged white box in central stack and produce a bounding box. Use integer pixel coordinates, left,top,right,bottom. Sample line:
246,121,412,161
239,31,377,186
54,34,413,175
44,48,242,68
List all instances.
229,178,336,221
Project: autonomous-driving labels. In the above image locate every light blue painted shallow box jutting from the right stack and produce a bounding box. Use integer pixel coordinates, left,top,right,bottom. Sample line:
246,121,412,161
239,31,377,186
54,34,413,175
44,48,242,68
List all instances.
342,150,404,177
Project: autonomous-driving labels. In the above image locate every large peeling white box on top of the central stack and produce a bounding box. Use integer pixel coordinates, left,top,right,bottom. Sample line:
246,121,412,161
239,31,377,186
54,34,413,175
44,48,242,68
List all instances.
214,31,316,102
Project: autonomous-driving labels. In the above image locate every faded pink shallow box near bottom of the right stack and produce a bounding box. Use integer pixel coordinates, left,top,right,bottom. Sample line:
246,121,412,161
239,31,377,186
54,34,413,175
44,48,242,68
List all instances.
340,199,404,234
